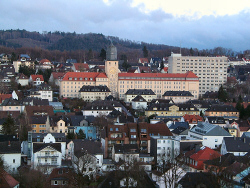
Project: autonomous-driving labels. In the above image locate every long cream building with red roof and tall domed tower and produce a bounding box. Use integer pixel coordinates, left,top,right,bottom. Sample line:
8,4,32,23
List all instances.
60,45,199,99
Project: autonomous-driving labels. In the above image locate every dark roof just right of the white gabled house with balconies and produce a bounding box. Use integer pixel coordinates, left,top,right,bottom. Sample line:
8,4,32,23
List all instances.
72,139,103,158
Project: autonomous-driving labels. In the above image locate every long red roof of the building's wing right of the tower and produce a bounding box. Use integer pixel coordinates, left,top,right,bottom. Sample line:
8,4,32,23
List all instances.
118,71,199,81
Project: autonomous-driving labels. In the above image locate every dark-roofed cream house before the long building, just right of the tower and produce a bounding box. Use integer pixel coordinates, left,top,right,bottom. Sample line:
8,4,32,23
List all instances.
124,89,156,103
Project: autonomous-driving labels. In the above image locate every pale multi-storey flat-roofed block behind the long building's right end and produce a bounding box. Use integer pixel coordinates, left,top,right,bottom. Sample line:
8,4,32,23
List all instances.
168,53,228,95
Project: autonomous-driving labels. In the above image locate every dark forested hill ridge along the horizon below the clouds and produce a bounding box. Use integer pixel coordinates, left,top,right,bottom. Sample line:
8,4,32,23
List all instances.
0,30,174,51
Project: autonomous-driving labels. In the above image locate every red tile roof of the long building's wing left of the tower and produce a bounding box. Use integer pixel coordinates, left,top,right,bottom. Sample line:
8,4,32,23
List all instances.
62,72,107,81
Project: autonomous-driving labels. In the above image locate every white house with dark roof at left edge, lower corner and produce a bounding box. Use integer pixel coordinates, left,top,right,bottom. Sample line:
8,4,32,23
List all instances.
0,141,21,174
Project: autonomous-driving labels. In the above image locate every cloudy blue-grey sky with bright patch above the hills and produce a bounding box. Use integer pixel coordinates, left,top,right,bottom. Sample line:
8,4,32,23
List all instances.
0,0,250,52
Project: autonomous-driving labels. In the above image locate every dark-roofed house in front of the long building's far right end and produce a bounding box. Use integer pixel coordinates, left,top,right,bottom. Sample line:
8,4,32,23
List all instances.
162,91,194,103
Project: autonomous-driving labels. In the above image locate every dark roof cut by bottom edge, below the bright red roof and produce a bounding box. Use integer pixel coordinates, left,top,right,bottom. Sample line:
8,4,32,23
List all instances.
178,172,220,188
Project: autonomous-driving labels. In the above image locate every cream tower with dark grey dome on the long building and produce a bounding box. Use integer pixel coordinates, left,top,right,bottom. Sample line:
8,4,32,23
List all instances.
105,43,119,97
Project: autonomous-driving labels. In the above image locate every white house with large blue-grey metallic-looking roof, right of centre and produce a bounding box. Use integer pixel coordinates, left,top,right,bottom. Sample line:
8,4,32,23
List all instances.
188,122,232,149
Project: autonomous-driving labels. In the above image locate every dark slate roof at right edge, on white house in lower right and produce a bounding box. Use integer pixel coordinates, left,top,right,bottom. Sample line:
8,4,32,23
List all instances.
224,137,250,152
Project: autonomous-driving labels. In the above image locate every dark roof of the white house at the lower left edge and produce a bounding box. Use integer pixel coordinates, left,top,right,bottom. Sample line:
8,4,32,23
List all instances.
0,141,21,154
